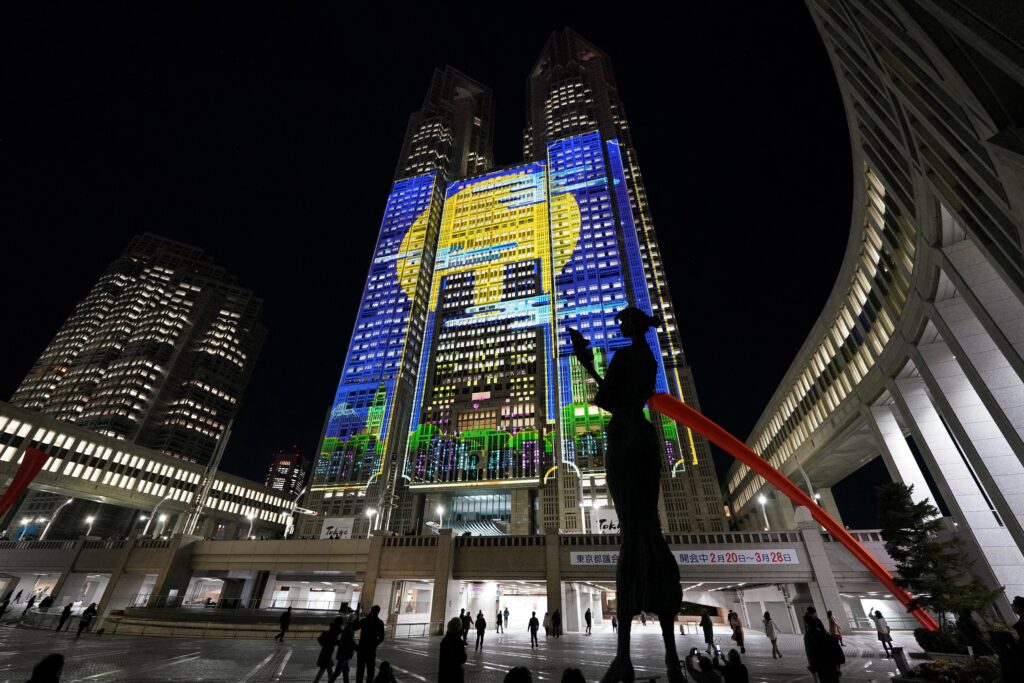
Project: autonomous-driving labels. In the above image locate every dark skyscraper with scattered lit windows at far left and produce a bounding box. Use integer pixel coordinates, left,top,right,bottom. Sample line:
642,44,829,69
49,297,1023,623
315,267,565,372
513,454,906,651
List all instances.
10,234,265,464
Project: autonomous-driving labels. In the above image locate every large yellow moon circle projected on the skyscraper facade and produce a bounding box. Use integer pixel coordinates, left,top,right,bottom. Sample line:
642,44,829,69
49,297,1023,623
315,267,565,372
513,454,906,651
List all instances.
397,166,581,310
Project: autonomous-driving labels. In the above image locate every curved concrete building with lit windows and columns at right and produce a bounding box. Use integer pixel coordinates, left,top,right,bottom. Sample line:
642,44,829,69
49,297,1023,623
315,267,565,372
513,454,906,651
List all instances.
727,0,1024,616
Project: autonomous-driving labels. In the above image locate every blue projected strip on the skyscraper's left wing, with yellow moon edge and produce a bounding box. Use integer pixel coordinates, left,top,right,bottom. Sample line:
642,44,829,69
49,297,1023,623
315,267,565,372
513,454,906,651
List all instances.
315,174,440,486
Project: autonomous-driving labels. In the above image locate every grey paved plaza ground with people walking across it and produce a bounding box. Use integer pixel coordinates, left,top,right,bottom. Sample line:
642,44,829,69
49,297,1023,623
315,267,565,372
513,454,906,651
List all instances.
0,625,916,683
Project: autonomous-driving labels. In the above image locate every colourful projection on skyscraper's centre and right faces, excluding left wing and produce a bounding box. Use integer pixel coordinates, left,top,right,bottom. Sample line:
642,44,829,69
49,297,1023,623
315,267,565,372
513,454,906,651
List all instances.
404,133,679,486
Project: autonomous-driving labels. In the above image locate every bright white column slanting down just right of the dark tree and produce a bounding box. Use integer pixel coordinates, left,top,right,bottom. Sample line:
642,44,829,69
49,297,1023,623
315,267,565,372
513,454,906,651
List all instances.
892,377,1024,613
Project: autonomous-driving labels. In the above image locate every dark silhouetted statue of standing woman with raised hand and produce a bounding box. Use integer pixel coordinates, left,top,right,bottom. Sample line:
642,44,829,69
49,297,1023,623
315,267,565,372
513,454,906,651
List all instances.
569,306,685,683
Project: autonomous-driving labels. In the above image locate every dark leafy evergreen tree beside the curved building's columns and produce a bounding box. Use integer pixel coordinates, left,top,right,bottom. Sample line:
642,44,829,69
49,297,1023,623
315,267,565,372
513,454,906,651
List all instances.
879,482,1002,627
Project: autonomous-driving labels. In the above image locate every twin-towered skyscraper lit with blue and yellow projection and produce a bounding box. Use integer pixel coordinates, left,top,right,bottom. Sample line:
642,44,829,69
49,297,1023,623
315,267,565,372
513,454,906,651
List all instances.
299,31,724,536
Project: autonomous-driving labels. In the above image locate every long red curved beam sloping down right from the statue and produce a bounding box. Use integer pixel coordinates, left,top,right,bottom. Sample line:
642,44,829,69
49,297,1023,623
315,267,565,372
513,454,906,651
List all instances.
647,393,939,631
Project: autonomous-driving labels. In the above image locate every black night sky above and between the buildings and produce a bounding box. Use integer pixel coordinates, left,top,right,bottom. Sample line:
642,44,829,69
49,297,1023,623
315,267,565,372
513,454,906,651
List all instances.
0,1,878,526
